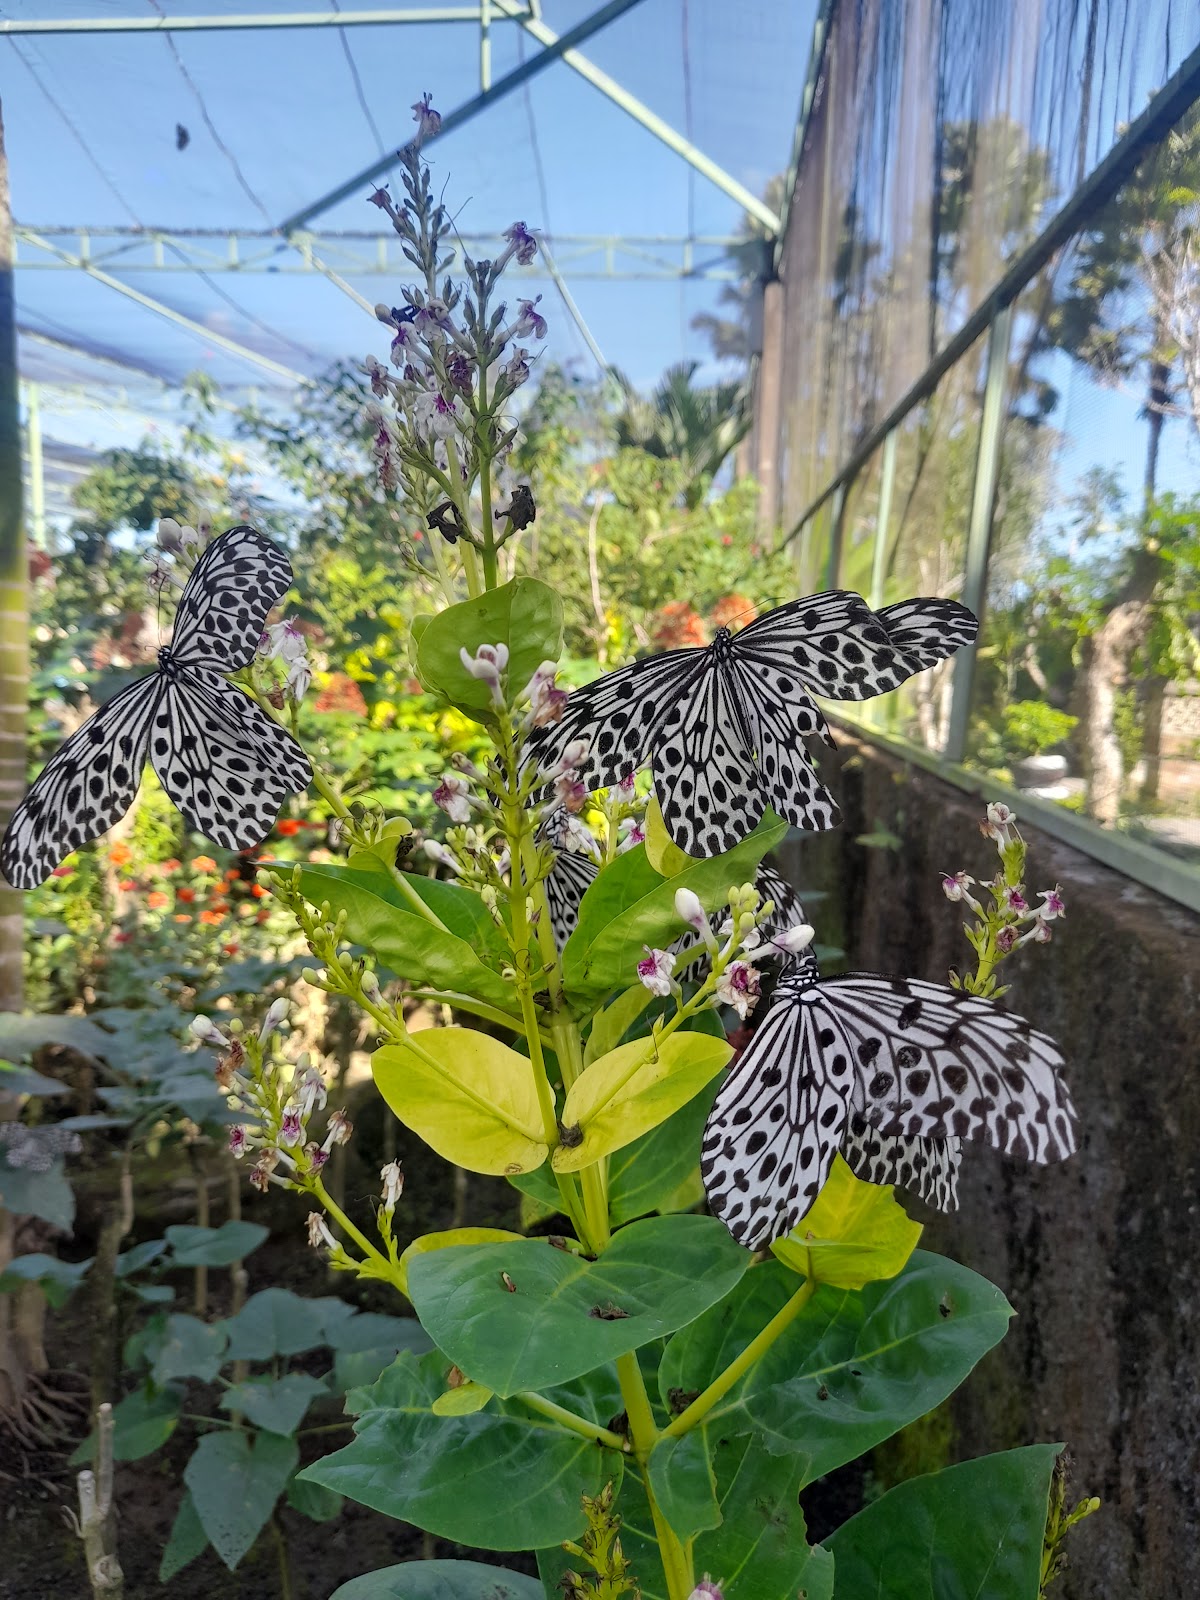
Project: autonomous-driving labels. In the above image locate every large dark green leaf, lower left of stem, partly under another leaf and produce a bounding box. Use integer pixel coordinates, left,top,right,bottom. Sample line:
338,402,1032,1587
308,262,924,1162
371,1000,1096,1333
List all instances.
302,1350,622,1550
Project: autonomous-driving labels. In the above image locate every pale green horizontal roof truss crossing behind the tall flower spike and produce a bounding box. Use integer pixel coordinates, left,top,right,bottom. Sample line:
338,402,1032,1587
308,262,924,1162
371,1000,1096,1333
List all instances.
14,222,738,283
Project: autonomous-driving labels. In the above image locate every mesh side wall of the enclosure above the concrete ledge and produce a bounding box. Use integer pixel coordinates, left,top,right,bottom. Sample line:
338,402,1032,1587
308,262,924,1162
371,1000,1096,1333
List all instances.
750,0,1200,909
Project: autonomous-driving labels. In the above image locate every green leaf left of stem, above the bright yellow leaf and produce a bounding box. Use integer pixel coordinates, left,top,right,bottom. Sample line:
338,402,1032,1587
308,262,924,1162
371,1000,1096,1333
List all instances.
299,864,518,1016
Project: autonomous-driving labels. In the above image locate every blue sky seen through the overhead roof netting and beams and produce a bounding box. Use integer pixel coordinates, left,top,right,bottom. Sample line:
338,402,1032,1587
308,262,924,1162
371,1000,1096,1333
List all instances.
0,0,816,512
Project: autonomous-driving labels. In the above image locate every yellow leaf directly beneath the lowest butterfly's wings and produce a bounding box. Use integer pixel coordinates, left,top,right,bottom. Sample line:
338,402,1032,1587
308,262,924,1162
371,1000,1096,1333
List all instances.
771,1155,922,1290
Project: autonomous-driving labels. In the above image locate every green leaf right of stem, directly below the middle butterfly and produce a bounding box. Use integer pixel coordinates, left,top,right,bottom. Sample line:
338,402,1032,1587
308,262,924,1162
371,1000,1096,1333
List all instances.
563,811,787,1010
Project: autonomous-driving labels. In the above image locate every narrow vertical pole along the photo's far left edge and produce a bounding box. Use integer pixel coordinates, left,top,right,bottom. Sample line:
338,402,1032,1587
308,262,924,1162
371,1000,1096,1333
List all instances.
0,93,29,1011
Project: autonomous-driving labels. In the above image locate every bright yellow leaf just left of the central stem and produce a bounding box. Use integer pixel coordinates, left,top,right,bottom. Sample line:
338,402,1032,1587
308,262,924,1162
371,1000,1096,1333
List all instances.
371,1027,549,1176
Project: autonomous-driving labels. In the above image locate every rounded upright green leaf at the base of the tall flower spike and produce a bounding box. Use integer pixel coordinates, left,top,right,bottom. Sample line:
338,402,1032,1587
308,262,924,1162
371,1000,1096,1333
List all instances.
416,578,563,720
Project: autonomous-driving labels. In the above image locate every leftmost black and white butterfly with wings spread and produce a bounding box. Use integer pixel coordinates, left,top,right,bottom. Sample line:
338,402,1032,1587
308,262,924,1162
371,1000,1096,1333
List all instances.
0,526,312,890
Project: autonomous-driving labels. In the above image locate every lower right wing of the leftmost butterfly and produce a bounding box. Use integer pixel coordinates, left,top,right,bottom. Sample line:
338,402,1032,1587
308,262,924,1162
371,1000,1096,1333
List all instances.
150,667,312,850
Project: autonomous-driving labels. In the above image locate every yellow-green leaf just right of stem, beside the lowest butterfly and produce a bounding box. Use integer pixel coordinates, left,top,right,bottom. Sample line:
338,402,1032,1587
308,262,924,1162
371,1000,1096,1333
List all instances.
554,1032,733,1173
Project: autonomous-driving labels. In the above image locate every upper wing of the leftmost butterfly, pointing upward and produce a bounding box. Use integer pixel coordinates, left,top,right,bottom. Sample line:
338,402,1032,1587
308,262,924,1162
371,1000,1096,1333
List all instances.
171,525,291,672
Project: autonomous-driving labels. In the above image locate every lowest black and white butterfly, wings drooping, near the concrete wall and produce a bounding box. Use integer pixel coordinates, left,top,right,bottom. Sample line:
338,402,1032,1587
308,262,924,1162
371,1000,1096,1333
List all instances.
701,950,1075,1250
